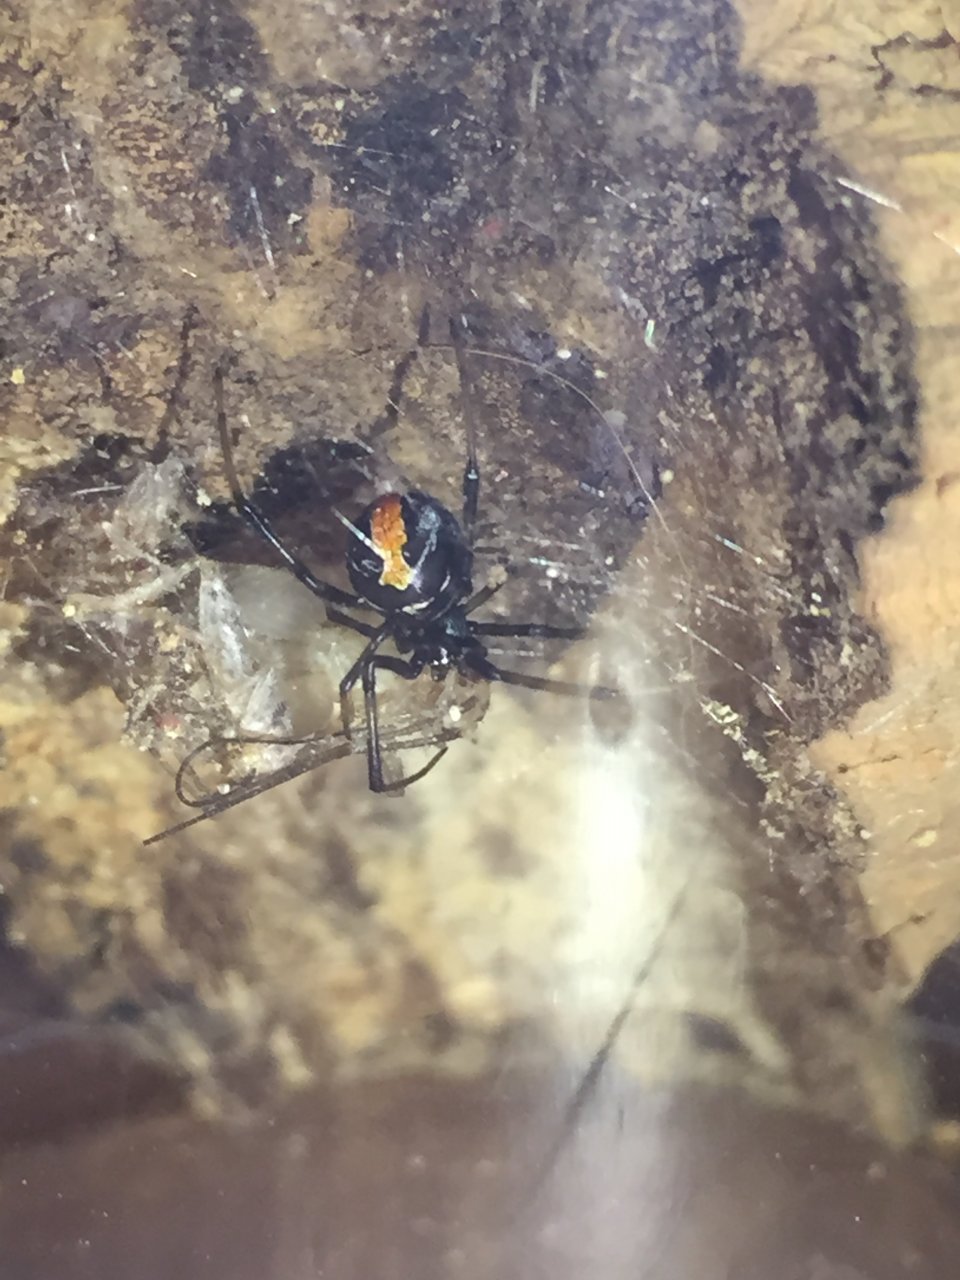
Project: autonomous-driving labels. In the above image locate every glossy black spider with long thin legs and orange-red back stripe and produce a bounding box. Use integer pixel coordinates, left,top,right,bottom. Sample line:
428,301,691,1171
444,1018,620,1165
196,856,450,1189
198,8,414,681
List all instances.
152,321,617,838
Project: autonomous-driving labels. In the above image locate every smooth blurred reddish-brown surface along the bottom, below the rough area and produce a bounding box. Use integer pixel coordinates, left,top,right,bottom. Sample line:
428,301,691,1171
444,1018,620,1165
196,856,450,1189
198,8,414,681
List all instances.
0,1075,960,1280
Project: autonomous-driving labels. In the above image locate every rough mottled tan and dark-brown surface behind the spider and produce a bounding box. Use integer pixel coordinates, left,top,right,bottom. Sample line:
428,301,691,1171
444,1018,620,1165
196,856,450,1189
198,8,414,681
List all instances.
0,0,960,1259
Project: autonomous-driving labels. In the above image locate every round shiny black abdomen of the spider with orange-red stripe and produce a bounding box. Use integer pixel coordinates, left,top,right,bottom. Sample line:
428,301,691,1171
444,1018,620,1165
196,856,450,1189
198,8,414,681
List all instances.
347,489,472,620
